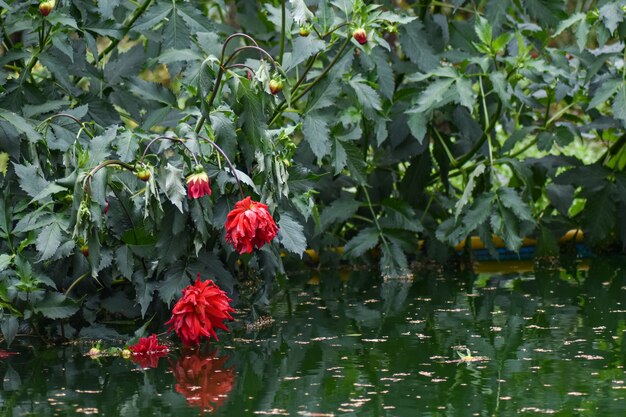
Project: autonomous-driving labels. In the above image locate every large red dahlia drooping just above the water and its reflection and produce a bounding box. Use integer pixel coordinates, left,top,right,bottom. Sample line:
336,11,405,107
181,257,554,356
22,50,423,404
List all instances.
165,274,235,346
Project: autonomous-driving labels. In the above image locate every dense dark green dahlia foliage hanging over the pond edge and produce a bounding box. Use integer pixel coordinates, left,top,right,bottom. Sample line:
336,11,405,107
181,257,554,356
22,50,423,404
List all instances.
0,0,626,342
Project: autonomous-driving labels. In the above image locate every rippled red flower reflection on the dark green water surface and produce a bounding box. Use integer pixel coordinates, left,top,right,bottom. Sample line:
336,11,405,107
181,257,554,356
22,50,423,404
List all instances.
171,352,235,413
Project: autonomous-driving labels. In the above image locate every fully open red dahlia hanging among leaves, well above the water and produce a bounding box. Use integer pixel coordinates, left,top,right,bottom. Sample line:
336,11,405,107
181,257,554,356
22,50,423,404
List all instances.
226,197,278,253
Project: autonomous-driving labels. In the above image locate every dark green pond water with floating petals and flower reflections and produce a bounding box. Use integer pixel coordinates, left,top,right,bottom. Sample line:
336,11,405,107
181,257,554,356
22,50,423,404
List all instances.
0,255,626,417
